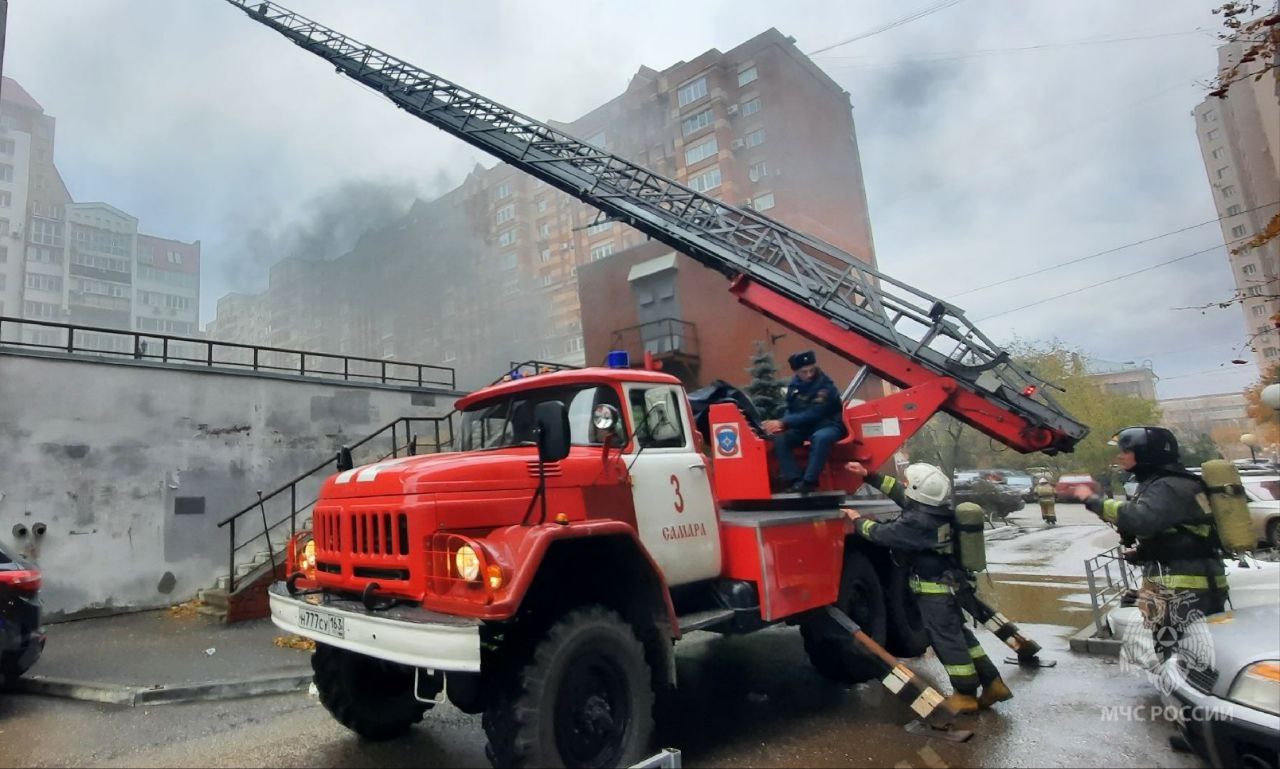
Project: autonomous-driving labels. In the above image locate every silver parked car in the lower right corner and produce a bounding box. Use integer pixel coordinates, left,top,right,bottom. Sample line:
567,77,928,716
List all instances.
1161,603,1280,766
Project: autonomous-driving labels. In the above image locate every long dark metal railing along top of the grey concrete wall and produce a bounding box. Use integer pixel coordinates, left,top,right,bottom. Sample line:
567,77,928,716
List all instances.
0,316,457,390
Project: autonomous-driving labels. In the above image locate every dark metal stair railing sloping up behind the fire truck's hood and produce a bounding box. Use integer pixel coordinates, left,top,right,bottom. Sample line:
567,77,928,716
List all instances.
218,411,457,592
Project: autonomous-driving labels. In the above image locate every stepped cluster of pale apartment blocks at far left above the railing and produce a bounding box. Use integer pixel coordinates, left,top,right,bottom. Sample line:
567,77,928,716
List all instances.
0,78,200,352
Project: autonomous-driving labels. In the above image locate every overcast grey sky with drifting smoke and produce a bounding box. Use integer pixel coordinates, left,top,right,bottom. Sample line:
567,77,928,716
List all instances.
4,0,1257,397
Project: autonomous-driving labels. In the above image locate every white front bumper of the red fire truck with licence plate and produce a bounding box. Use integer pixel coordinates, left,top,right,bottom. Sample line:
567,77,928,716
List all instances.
268,582,481,673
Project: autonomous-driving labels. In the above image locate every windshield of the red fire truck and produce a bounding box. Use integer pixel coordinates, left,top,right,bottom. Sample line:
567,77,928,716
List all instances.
460,385,621,452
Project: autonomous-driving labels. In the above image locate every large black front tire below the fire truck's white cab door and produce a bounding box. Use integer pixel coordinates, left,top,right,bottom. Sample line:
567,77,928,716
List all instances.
484,606,654,766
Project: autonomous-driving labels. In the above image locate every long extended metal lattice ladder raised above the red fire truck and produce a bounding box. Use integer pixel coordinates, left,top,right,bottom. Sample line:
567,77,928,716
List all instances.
227,0,1088,454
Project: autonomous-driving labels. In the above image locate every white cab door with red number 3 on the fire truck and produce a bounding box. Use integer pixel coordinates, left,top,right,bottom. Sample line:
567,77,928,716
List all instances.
623,383,721,585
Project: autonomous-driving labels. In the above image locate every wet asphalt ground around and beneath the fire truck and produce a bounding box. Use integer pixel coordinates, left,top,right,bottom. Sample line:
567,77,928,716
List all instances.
0,505,1203,769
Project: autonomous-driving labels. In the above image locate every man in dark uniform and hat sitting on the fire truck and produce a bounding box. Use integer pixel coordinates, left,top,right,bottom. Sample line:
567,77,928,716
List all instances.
762,349,845,494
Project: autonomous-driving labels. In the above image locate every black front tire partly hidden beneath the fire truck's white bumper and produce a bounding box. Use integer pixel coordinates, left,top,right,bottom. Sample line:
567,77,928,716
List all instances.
311,644,430,741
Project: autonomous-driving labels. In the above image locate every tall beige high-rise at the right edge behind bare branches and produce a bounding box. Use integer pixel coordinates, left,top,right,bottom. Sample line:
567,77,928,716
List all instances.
1192,42,1280,372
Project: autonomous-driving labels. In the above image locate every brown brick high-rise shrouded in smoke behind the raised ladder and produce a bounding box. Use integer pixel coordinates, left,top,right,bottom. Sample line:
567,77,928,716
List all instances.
211,29,874,384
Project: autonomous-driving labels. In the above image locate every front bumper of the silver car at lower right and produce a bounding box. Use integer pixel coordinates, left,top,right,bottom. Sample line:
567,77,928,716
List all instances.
1161,658,1280,766
